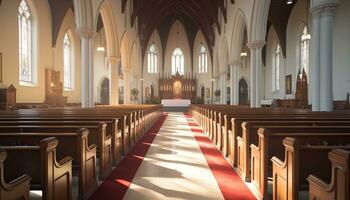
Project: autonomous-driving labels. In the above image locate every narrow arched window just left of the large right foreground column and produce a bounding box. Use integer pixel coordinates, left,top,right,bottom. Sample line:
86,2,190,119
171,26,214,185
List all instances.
300,26,311,75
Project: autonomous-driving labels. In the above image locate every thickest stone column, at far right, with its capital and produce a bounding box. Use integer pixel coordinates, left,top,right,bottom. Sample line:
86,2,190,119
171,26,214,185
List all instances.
310,0,339,111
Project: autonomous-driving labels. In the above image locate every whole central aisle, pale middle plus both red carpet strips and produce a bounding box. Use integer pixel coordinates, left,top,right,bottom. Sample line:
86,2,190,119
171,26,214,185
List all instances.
90,113,256,200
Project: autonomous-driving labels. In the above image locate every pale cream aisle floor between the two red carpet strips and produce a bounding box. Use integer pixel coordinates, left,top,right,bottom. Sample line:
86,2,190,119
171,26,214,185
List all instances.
124,113,224,200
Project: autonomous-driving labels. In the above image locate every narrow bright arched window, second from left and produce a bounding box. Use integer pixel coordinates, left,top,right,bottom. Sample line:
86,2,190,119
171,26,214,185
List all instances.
63,33,73,90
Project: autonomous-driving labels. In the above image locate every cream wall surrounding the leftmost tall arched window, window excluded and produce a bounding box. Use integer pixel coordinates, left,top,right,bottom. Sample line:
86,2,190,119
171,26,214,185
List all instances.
0,0,52,103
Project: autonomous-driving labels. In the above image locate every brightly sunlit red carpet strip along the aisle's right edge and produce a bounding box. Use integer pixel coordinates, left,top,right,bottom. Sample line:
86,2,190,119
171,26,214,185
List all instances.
185,114,256,200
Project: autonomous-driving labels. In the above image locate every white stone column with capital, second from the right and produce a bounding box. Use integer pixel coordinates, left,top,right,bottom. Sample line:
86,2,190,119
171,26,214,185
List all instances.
248,41,265,108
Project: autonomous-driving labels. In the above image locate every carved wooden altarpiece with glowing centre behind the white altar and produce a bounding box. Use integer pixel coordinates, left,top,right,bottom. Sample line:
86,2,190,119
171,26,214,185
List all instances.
159,73,197,100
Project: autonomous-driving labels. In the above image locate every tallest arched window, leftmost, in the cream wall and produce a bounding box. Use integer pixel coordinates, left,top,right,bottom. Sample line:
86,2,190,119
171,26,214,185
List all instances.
18,0,34,84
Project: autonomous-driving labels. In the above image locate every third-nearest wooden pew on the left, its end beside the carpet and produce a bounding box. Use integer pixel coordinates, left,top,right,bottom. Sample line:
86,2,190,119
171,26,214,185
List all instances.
0,129,97,199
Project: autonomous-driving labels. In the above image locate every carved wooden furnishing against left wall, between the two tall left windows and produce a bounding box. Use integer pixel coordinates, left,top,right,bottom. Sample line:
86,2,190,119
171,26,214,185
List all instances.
45,69,67,106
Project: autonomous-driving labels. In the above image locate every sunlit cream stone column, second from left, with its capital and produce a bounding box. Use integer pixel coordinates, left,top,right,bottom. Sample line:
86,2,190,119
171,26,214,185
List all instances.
106,57,119,105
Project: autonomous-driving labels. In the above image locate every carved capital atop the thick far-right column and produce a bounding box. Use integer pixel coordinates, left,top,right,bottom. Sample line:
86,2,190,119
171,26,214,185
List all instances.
310,0,339,17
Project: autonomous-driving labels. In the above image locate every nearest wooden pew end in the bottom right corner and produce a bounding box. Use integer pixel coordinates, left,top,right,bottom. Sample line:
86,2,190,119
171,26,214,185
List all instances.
307,149,350,200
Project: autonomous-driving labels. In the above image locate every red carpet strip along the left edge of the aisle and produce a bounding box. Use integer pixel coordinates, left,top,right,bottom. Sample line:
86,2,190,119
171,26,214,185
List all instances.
90,114,167,200
